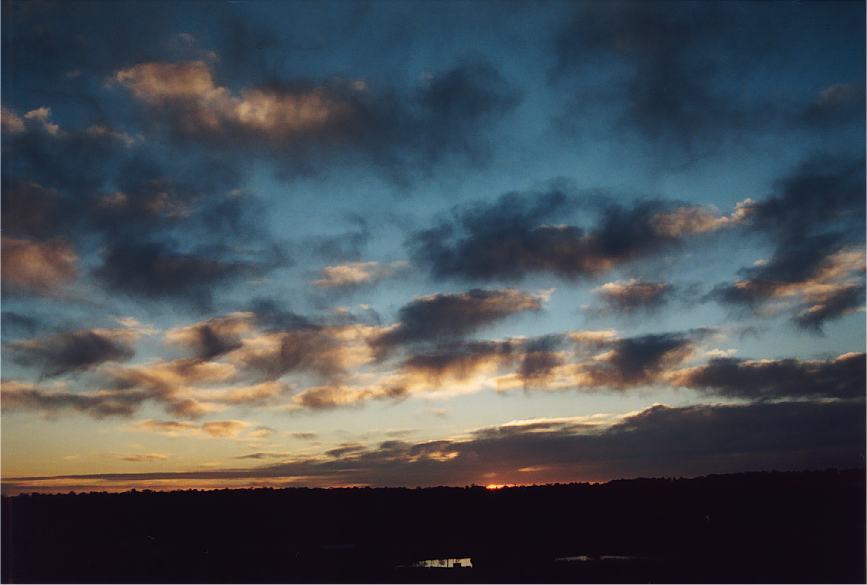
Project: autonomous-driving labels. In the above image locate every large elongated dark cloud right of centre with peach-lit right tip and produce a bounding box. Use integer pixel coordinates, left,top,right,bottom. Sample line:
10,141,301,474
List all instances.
407,182,746,280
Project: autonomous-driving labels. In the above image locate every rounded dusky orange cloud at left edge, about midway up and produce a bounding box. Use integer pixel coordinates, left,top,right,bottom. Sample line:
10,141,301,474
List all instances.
0,237,78,296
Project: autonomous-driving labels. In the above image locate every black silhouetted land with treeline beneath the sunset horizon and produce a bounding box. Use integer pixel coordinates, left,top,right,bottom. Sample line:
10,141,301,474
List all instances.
2,470,867,583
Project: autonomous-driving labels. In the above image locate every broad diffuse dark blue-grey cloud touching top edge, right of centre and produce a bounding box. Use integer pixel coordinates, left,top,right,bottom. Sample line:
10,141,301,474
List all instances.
555,2,760,154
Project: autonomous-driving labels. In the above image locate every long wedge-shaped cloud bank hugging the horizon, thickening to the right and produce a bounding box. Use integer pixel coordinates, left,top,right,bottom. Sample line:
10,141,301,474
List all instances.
5,401,865,489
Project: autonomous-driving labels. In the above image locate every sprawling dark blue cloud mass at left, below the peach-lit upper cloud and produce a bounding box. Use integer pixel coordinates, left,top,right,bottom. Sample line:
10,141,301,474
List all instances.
2,101,290,308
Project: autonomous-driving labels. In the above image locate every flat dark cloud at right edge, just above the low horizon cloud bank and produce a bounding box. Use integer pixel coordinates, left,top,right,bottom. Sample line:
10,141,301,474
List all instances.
674,353,867,400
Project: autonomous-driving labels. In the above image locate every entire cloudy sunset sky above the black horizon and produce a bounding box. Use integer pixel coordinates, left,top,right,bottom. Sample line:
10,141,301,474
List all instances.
0,0,865,494
